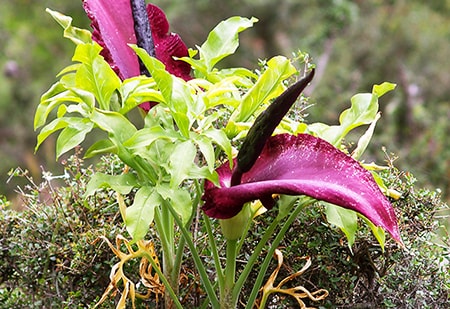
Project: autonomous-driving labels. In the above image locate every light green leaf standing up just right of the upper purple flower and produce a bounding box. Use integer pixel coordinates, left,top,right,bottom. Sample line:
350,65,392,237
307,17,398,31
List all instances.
198,16,258,72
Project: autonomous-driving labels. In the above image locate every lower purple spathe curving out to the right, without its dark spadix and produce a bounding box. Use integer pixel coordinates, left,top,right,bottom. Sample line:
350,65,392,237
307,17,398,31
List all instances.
203,134,400,241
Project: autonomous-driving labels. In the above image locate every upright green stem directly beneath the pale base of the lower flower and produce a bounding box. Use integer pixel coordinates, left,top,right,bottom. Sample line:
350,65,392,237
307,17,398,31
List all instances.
220,239,239,309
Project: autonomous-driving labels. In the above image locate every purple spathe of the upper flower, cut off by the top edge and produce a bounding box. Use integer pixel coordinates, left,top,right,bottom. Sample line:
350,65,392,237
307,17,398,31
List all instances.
83,0,191,111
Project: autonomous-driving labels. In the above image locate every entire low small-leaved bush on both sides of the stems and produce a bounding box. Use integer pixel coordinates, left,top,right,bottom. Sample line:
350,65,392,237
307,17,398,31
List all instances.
0,149,450,308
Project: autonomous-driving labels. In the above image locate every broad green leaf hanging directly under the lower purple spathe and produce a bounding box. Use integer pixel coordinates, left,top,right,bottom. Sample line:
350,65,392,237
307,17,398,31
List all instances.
324,203,358,251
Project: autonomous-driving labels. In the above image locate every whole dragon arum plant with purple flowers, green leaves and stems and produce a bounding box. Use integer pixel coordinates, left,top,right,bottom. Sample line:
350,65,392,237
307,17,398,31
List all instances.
34,0,401,308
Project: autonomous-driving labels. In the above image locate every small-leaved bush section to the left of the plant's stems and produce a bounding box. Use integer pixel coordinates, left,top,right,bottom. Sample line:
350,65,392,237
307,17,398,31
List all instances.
0,149,123,308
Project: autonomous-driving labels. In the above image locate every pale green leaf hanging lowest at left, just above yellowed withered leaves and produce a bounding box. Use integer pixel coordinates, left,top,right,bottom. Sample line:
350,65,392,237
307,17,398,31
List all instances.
125,187,162,242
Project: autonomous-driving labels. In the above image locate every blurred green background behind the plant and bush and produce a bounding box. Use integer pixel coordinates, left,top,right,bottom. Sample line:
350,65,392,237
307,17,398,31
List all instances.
0,0,450,206
